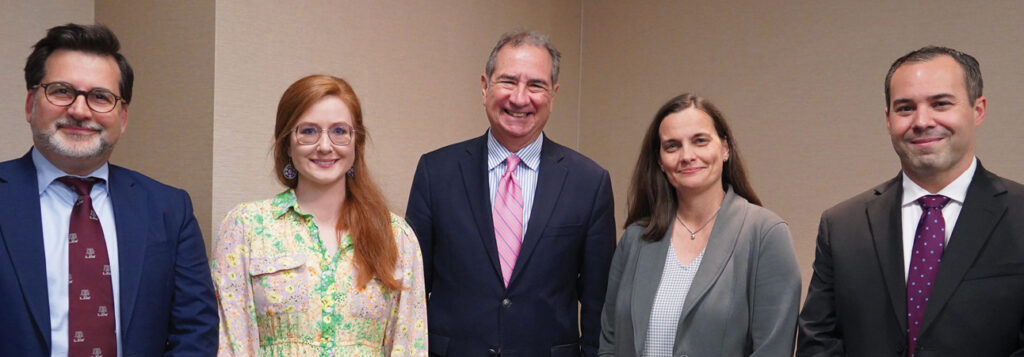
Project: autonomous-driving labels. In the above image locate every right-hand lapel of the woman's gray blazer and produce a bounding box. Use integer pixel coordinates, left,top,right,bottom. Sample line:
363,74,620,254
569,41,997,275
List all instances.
676,188,748,323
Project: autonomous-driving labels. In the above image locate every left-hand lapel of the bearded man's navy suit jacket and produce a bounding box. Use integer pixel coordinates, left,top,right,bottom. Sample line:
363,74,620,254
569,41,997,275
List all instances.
0,152,51,346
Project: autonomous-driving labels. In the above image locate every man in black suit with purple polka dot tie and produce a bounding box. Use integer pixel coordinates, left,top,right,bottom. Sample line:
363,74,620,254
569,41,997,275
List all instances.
797,47,1024,357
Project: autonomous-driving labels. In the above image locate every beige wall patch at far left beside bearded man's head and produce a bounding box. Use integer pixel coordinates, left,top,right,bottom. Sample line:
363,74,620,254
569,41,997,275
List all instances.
0,0,93,161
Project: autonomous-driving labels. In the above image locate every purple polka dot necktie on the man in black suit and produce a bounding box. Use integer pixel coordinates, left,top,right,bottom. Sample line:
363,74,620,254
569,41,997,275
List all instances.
906,194,949,356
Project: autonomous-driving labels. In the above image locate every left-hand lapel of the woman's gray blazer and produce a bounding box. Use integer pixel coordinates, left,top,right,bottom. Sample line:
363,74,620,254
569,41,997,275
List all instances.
630,226,672,356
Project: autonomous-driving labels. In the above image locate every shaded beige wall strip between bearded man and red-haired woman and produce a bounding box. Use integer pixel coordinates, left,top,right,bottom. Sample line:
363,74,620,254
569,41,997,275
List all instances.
96,0,214,239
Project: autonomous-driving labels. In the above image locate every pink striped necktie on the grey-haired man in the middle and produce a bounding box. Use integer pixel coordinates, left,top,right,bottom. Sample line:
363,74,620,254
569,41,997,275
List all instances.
493,154,522,287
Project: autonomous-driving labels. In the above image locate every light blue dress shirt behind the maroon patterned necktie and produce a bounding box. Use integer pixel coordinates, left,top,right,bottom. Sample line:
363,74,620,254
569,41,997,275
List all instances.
32,148,122,357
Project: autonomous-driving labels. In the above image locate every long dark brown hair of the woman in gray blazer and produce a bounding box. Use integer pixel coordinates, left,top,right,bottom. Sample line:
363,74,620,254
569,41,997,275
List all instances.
624,93,761,241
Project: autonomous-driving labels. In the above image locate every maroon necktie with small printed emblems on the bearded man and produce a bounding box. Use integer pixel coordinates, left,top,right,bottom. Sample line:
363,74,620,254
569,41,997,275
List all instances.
57,176,117,357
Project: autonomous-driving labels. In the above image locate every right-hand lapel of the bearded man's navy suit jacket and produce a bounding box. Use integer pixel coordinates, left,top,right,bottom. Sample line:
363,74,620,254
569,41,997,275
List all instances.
109,165,150,333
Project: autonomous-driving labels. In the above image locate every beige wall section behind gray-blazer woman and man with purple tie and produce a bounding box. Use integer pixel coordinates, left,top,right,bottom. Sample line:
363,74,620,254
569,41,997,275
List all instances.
581,1,1024,296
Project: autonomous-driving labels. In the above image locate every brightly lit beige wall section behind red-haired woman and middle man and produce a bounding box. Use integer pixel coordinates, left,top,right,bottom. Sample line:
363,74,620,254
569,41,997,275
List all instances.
213,0,580,231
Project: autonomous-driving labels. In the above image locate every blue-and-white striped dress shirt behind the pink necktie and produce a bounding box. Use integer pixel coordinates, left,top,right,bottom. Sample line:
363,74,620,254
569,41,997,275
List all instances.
487,129,544,236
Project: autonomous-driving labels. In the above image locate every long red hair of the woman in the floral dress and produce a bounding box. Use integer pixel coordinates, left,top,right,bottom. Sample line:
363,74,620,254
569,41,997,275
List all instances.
273,75,401,291
